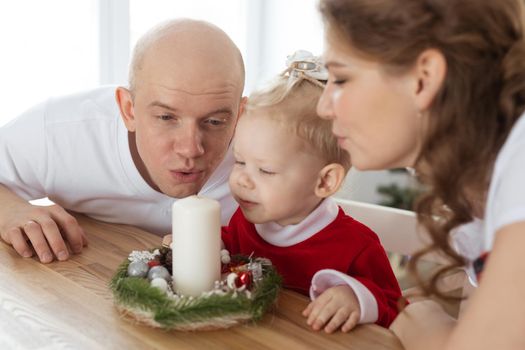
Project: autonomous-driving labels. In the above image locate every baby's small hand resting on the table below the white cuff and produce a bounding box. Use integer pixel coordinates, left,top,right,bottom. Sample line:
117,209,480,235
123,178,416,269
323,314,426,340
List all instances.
303,285,361,333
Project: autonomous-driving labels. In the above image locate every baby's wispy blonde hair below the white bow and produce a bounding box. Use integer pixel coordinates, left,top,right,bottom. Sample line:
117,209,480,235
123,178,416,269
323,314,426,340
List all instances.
243,75,351,171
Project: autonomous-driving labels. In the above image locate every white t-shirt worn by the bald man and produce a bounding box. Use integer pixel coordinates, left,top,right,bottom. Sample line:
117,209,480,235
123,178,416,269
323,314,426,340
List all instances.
0,87,237,235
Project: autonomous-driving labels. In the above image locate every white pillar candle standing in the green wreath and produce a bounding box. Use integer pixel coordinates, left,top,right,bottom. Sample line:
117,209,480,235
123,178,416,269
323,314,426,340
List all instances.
172,196,221,296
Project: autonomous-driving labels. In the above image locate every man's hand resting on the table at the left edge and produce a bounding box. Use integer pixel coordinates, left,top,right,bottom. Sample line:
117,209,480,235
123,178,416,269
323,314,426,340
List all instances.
0,201,87,263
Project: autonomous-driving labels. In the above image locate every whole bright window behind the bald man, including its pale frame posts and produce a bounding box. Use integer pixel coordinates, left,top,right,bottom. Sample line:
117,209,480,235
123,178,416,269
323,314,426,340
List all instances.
0,0,322,126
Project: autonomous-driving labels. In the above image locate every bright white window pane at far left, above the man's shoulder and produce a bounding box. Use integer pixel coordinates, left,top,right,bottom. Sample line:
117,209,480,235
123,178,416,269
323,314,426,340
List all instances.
0,0,99,126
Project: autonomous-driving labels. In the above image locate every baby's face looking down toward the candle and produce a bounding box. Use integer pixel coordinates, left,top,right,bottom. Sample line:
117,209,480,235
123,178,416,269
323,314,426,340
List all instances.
230,112,325,226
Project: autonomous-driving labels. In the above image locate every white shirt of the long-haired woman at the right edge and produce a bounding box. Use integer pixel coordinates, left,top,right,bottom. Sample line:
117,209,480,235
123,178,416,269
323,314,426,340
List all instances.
454,115,525,282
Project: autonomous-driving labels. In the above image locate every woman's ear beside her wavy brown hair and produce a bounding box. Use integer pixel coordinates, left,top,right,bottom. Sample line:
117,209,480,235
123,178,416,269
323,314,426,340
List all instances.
414,49,447,111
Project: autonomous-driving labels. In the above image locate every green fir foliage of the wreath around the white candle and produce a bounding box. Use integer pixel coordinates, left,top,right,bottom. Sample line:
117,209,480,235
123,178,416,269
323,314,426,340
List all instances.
109,252,282,329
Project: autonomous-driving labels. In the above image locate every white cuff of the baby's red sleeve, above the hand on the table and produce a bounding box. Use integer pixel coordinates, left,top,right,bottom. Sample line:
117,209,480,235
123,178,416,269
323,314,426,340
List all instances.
310,269,379,323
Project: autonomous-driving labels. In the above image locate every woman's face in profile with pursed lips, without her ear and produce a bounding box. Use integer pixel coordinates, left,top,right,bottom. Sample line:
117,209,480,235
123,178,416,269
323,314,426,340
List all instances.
317,36,425,170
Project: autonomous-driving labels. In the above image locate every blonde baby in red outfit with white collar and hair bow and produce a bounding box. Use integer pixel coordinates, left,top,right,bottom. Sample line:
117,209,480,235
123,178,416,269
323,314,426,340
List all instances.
222,51,401,332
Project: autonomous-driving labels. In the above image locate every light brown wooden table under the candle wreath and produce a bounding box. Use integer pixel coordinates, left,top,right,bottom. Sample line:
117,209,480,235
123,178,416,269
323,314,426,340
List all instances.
0,215,402,350
